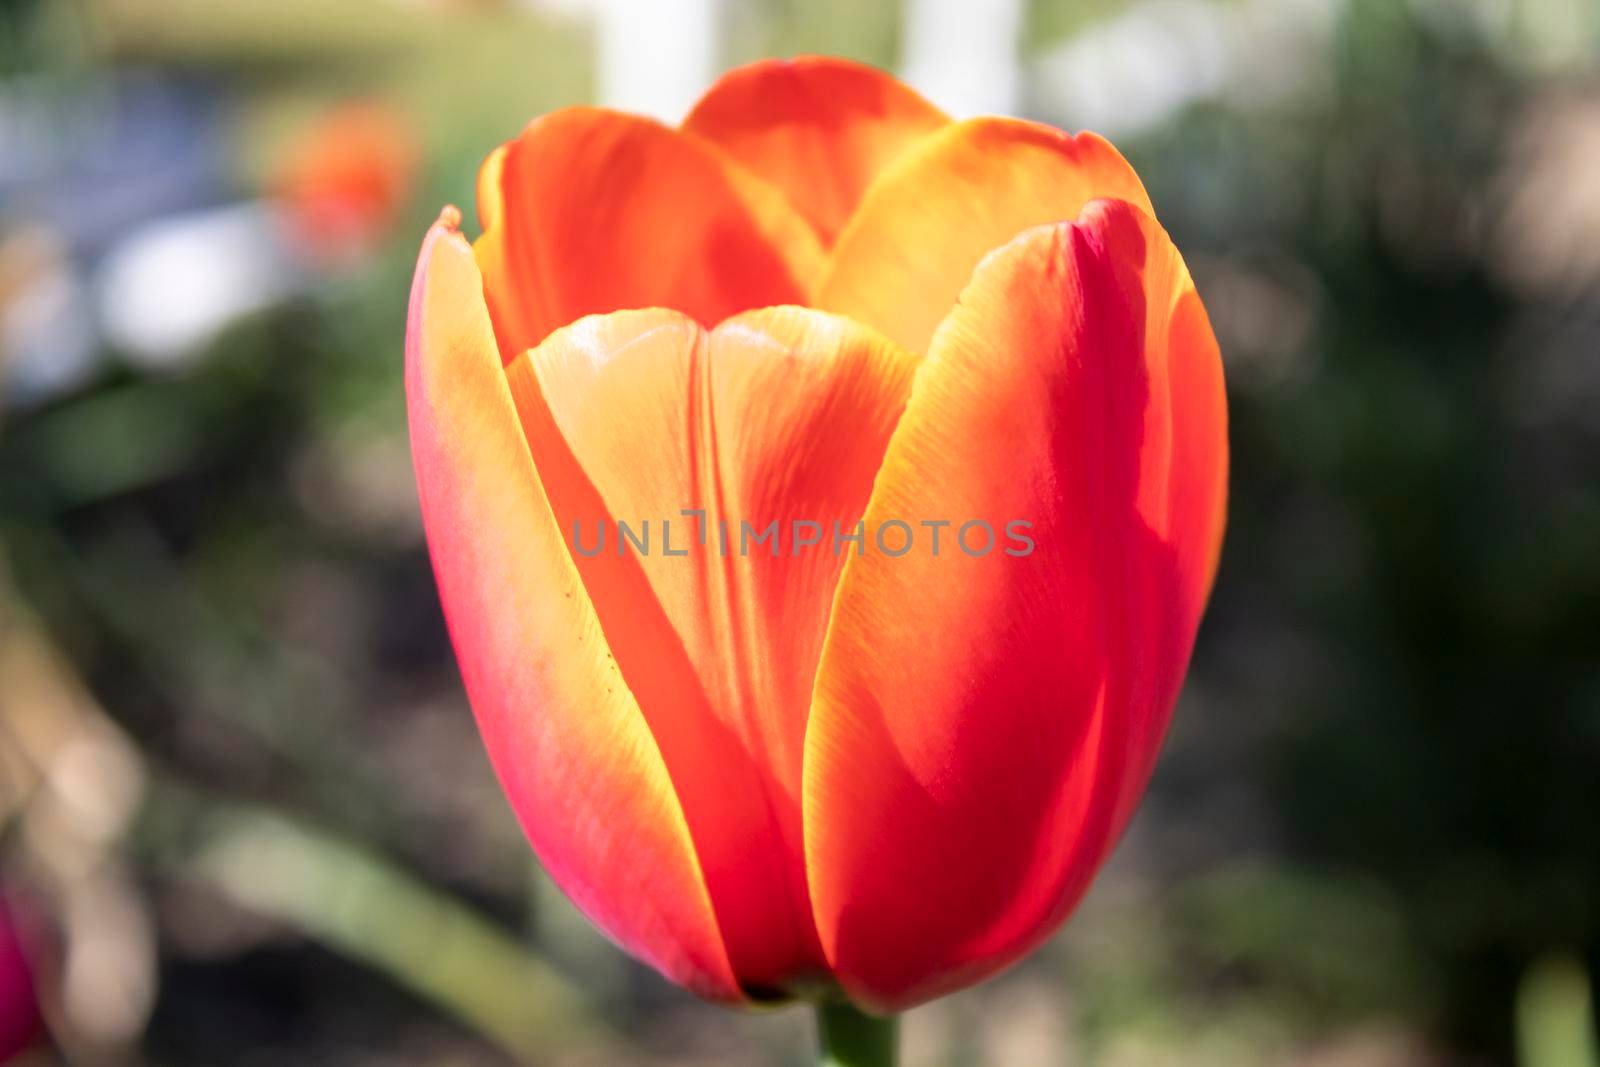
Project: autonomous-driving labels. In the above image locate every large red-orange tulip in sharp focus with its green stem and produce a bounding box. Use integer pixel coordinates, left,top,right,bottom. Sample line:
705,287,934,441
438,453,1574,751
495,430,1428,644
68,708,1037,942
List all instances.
406,58,1227,1062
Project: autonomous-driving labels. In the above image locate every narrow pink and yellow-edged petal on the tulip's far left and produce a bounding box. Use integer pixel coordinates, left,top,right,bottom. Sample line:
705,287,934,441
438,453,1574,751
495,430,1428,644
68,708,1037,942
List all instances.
406,210,742,1000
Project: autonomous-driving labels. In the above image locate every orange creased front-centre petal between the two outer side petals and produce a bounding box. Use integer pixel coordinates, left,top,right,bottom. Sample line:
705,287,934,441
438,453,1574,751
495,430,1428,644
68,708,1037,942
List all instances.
507,307,914,997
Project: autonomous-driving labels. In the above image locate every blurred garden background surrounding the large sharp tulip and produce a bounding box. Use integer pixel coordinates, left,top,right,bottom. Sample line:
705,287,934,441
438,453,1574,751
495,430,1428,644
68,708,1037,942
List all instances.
0,0,1600,1067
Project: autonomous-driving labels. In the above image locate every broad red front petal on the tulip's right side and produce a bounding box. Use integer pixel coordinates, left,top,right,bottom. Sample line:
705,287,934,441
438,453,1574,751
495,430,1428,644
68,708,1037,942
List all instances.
803,202,1227,1009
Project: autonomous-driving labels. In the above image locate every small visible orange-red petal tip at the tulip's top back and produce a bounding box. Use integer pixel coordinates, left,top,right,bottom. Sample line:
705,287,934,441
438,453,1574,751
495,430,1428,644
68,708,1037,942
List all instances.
683,56,949,251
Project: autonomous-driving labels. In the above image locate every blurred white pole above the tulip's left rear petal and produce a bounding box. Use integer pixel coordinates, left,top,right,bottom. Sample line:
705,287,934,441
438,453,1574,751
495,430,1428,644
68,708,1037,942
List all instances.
595,0,720,123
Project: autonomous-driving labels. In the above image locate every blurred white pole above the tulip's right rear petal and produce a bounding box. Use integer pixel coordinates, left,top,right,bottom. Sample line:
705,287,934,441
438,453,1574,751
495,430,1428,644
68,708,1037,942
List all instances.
904,0,1022,118
